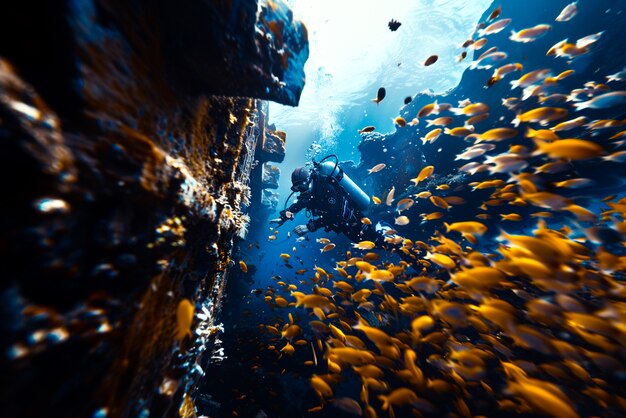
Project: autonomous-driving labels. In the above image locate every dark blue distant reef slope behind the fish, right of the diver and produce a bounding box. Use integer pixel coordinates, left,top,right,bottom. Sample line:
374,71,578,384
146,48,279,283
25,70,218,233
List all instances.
358,0,626,239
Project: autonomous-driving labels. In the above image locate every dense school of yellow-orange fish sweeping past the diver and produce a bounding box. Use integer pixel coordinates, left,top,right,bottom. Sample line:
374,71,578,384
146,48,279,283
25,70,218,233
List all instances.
250,3,626,418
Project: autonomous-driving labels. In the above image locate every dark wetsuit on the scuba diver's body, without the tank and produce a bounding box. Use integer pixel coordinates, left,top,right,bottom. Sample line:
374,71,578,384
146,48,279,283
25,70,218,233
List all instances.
280,173,385,246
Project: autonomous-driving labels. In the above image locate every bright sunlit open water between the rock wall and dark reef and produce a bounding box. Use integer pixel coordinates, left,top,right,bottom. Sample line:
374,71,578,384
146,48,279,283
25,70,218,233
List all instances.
257,0,490,290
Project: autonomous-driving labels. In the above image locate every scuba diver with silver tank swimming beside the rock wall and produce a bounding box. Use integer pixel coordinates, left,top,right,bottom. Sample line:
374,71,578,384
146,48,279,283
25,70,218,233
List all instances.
270,155,391,247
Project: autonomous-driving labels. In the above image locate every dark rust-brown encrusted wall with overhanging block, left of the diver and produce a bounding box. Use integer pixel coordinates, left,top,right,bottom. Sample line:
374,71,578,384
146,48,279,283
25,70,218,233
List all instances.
0,0,308,417
